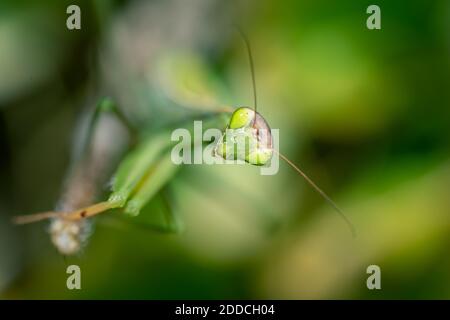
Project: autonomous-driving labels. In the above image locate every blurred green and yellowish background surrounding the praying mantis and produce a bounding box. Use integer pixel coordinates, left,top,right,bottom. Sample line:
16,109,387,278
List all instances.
0,0,450,299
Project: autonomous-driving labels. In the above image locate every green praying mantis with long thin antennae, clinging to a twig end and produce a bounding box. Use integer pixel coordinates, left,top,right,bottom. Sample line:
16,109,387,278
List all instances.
13,30,355,255
